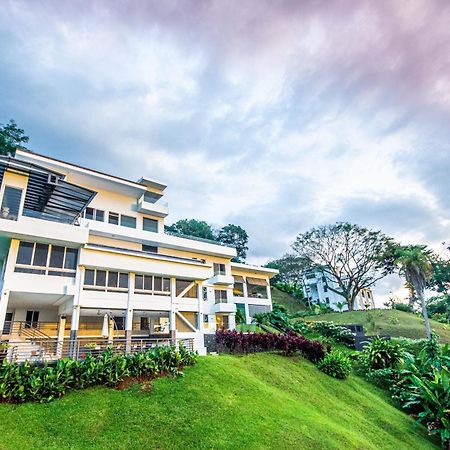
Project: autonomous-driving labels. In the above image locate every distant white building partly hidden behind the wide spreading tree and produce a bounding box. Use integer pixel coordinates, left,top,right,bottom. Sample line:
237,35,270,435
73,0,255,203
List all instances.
302,270,375,311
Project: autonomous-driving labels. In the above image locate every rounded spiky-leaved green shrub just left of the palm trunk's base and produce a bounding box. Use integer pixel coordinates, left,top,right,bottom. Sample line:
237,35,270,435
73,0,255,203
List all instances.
360,338,404,370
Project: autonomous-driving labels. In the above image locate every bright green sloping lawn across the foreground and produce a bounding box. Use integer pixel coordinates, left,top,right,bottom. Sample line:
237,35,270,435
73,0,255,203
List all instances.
0,354,438,450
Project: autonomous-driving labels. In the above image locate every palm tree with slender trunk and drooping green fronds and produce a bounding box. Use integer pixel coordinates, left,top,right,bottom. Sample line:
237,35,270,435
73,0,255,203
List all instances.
393,245,434,339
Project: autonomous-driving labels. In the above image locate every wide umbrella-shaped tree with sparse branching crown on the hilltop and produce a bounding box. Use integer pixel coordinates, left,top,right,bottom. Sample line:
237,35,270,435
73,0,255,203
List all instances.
292,222,391,311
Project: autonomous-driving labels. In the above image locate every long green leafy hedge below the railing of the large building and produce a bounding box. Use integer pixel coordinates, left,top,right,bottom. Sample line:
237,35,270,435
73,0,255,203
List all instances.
0,346,197,402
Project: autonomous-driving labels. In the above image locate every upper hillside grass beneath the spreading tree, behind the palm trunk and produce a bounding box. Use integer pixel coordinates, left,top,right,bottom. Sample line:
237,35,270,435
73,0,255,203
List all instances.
305,309,450,343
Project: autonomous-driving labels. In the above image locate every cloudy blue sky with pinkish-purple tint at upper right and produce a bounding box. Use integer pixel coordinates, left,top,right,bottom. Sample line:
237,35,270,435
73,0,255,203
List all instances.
0,0,450,302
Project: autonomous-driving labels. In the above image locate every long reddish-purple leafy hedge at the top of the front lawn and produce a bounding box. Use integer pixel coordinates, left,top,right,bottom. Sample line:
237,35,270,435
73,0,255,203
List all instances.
216,330,325,362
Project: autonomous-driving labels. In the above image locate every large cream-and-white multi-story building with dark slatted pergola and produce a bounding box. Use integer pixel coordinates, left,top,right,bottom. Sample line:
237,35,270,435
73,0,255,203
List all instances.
0,150,277,355
